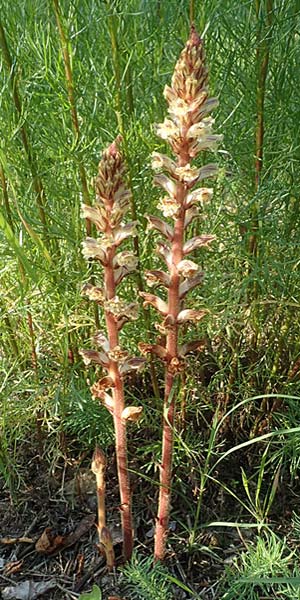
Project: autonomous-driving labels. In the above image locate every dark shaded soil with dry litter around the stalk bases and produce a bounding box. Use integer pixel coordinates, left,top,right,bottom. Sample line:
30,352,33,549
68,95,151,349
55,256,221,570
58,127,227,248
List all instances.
0,422,300,600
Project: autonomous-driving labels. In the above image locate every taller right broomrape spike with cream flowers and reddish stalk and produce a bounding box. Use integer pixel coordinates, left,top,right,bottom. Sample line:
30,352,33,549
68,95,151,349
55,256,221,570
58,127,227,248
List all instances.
140,26,222,560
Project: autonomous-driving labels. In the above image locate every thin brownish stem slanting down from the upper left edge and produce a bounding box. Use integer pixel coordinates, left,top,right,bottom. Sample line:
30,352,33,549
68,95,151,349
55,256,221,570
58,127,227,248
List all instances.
0,22,49,242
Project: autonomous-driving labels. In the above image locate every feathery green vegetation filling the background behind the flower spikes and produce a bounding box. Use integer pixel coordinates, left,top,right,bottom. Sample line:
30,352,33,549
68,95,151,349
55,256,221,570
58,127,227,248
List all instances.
0,0,300,599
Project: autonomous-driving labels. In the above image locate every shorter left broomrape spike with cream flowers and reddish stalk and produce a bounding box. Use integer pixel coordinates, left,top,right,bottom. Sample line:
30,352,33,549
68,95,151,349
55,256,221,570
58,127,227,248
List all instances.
81,138,144,560
